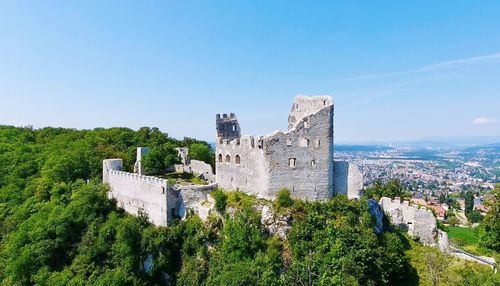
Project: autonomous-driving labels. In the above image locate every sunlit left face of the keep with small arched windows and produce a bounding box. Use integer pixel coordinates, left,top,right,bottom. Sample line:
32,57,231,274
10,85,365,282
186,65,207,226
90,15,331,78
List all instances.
215,136,269,196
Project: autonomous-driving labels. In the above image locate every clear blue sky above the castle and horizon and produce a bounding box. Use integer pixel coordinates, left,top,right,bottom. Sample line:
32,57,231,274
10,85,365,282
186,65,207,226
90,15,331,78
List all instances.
0,1,500,142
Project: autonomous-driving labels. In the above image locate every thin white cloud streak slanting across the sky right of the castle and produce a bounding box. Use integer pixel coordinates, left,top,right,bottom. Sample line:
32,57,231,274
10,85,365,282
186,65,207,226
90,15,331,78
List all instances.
344,53,500,81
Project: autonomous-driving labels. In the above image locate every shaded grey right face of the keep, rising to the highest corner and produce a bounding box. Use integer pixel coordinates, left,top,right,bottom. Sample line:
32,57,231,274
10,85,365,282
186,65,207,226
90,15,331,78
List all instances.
263,104,333,200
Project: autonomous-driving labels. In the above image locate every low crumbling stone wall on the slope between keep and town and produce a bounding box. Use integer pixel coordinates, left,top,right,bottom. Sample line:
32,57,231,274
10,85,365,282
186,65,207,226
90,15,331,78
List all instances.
380,197,437,245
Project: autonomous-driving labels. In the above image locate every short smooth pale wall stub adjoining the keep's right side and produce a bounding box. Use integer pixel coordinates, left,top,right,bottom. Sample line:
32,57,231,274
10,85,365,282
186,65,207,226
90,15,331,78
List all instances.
333,161,363,199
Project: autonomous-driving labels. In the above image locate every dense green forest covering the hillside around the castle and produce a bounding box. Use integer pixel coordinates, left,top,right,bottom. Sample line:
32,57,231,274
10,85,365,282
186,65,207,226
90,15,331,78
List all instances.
0,126,500,285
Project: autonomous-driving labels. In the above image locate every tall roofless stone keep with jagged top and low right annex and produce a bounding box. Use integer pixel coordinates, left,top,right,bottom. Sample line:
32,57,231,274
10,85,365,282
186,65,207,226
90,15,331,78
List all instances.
215,96,363,200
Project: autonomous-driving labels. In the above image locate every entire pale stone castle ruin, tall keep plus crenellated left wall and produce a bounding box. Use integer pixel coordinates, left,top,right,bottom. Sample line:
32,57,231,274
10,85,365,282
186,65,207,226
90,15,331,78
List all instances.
102,96,363,226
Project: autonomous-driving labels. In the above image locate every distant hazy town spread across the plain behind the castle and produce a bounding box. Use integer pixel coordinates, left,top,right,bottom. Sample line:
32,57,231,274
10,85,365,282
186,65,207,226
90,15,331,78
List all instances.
335,145,500,222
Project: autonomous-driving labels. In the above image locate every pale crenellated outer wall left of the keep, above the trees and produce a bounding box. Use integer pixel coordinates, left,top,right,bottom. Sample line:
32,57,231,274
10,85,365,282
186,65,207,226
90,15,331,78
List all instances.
103,159,170,226
